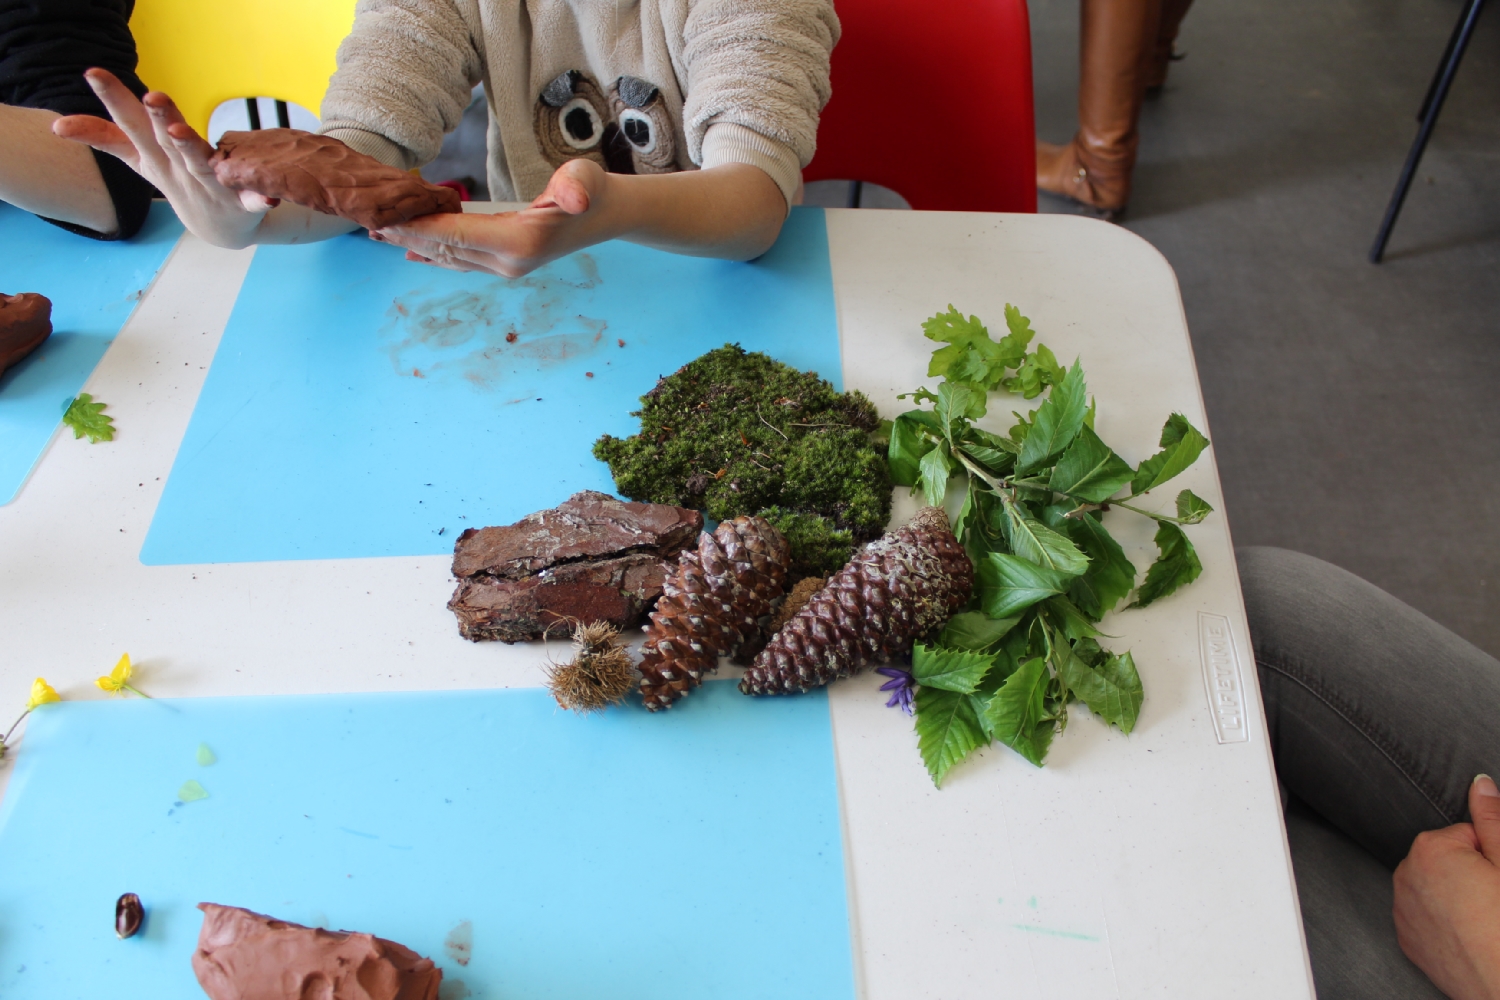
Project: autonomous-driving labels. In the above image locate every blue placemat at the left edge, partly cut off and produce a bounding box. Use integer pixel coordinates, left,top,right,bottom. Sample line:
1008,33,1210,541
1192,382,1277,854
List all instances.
0,201,183,504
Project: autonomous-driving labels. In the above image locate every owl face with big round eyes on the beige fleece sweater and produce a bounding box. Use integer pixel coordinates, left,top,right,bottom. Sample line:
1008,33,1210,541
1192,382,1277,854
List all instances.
536,69,678,174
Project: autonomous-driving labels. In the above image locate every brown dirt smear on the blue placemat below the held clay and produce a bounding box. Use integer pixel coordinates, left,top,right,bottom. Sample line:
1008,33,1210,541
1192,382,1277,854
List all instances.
381,253,608,391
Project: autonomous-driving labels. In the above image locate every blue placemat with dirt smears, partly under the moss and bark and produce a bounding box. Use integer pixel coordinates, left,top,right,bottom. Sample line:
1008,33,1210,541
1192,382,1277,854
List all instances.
141,208,840,565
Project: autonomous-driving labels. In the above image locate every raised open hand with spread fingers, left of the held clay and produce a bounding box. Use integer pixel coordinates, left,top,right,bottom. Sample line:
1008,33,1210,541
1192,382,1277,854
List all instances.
53,69,275,249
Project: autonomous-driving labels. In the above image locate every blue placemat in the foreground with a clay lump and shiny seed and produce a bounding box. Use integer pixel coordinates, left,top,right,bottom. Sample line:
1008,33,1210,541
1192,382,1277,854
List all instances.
0,682,854,1000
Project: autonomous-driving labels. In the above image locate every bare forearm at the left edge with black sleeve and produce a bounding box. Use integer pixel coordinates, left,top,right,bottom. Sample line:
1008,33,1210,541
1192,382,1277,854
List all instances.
0,105,120,235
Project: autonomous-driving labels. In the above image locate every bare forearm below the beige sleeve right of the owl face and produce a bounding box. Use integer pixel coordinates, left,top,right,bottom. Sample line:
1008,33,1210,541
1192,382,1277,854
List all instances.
594,163,786,261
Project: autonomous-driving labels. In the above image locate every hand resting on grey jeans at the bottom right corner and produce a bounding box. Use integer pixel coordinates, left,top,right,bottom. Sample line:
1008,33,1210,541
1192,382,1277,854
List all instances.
1394,775,1500,1000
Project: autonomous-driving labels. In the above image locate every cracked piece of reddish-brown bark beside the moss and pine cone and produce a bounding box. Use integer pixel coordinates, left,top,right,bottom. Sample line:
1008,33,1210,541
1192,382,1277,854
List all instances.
449,490,704,642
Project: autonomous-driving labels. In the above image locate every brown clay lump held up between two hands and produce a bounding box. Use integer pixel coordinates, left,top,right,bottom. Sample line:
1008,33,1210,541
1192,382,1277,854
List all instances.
212,129,462,229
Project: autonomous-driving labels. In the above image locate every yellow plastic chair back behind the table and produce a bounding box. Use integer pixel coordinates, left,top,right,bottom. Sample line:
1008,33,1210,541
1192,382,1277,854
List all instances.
131,0,356,135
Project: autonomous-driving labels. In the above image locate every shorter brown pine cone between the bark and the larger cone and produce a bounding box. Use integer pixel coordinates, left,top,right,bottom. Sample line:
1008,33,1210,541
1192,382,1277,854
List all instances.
641,517,792,712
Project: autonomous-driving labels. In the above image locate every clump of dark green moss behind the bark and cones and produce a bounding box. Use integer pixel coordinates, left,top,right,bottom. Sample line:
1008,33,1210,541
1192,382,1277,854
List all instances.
594,345,891,548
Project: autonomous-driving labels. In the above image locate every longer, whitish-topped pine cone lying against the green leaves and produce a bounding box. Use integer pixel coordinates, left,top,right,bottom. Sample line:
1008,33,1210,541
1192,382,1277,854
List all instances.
740,507,974,694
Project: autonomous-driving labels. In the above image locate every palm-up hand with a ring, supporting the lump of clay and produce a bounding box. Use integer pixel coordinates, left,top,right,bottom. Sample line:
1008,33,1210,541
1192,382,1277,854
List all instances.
371,159,606,277
